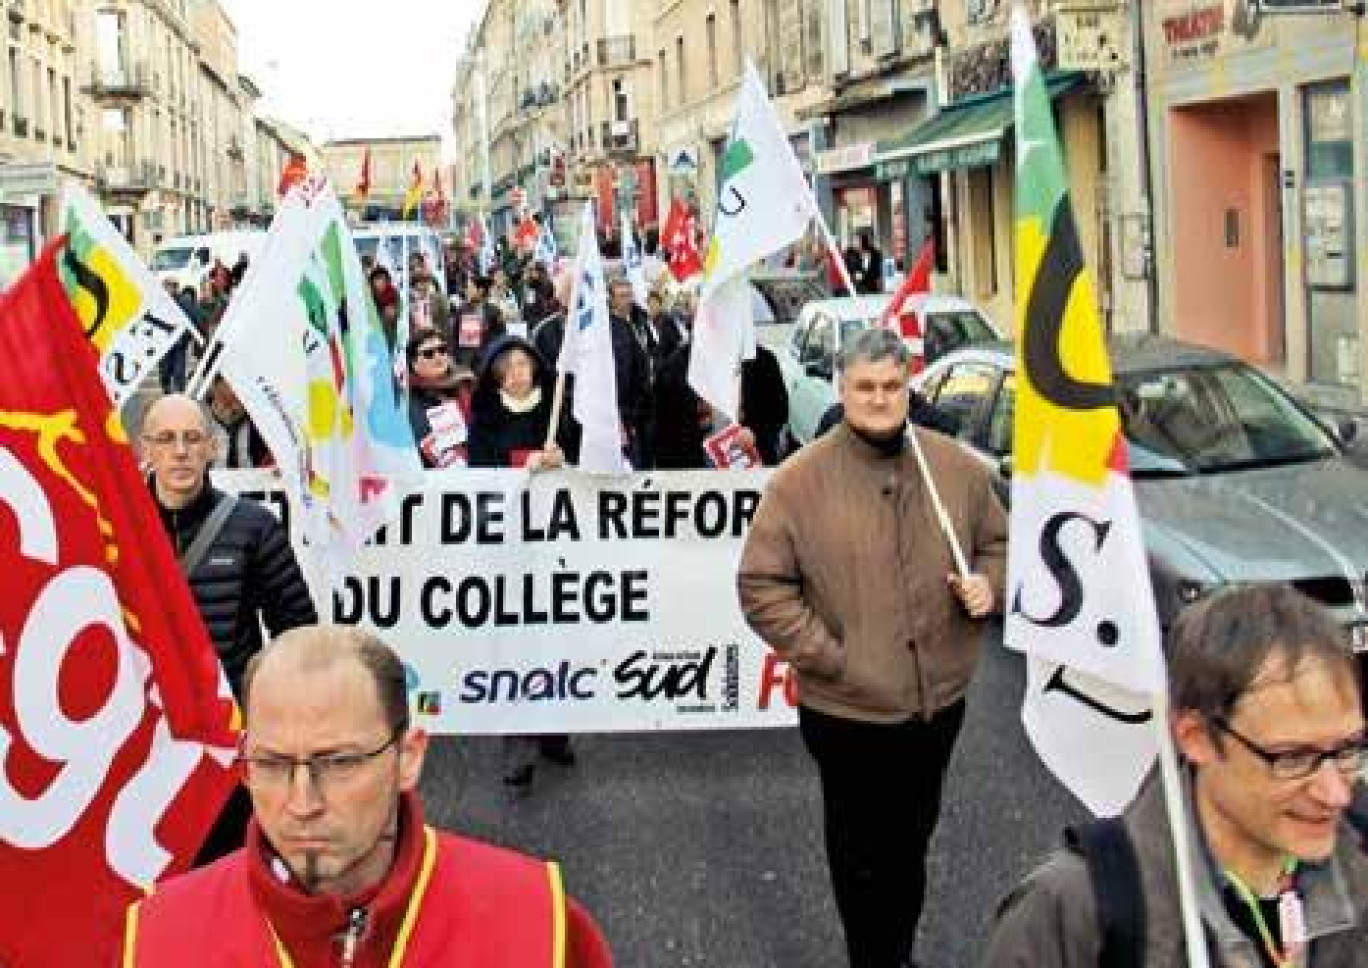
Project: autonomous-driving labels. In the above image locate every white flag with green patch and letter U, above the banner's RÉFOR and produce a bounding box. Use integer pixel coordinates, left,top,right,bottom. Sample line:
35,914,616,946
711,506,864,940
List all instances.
688,60,817,420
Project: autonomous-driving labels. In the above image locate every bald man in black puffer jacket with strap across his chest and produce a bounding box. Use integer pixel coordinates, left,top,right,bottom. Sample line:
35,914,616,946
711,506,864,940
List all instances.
141,394,319,863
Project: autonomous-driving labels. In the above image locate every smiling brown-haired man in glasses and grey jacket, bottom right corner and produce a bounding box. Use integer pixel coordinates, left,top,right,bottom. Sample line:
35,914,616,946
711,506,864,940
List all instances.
982,585,1368,968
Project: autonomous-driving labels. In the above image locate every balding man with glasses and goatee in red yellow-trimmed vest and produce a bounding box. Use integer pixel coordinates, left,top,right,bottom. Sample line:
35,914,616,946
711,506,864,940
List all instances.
123,626,611,968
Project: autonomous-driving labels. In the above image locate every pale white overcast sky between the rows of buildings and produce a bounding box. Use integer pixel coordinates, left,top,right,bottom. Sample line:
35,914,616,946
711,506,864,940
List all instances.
219,0,486,153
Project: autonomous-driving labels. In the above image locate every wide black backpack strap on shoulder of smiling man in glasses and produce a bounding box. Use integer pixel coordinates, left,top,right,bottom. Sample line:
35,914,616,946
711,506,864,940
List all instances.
1064,816,1145,968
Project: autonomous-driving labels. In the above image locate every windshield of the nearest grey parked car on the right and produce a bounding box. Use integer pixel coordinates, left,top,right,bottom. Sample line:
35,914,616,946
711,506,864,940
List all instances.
1118,362,1338,479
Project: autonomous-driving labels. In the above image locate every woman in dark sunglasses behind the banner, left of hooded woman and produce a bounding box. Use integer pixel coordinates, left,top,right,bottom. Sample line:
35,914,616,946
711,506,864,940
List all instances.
405,330,475,468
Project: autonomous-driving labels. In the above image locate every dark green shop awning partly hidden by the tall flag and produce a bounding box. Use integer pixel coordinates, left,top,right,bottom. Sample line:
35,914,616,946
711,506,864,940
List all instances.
874,72,1083,178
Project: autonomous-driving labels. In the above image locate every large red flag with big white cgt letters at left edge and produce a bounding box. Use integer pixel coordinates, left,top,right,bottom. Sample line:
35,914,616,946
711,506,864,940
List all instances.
0,238,235,968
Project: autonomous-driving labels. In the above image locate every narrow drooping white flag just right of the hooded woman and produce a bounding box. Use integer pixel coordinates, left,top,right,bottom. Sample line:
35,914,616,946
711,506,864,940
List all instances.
557,202,632,474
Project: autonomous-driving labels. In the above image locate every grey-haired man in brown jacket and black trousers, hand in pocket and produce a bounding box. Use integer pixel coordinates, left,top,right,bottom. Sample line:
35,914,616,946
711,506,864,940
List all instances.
737,330,1007,968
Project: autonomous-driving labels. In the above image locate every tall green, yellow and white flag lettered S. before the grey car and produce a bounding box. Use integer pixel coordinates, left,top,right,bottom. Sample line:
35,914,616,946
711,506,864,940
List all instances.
1005,7,1164,814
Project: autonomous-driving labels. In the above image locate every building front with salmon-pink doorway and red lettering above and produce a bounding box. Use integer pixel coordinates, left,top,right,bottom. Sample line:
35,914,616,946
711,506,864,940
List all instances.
1145,0,1368,406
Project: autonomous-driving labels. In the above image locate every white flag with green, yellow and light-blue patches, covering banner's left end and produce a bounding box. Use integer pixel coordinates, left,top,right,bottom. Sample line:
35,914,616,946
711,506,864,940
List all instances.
207,182,421,582
